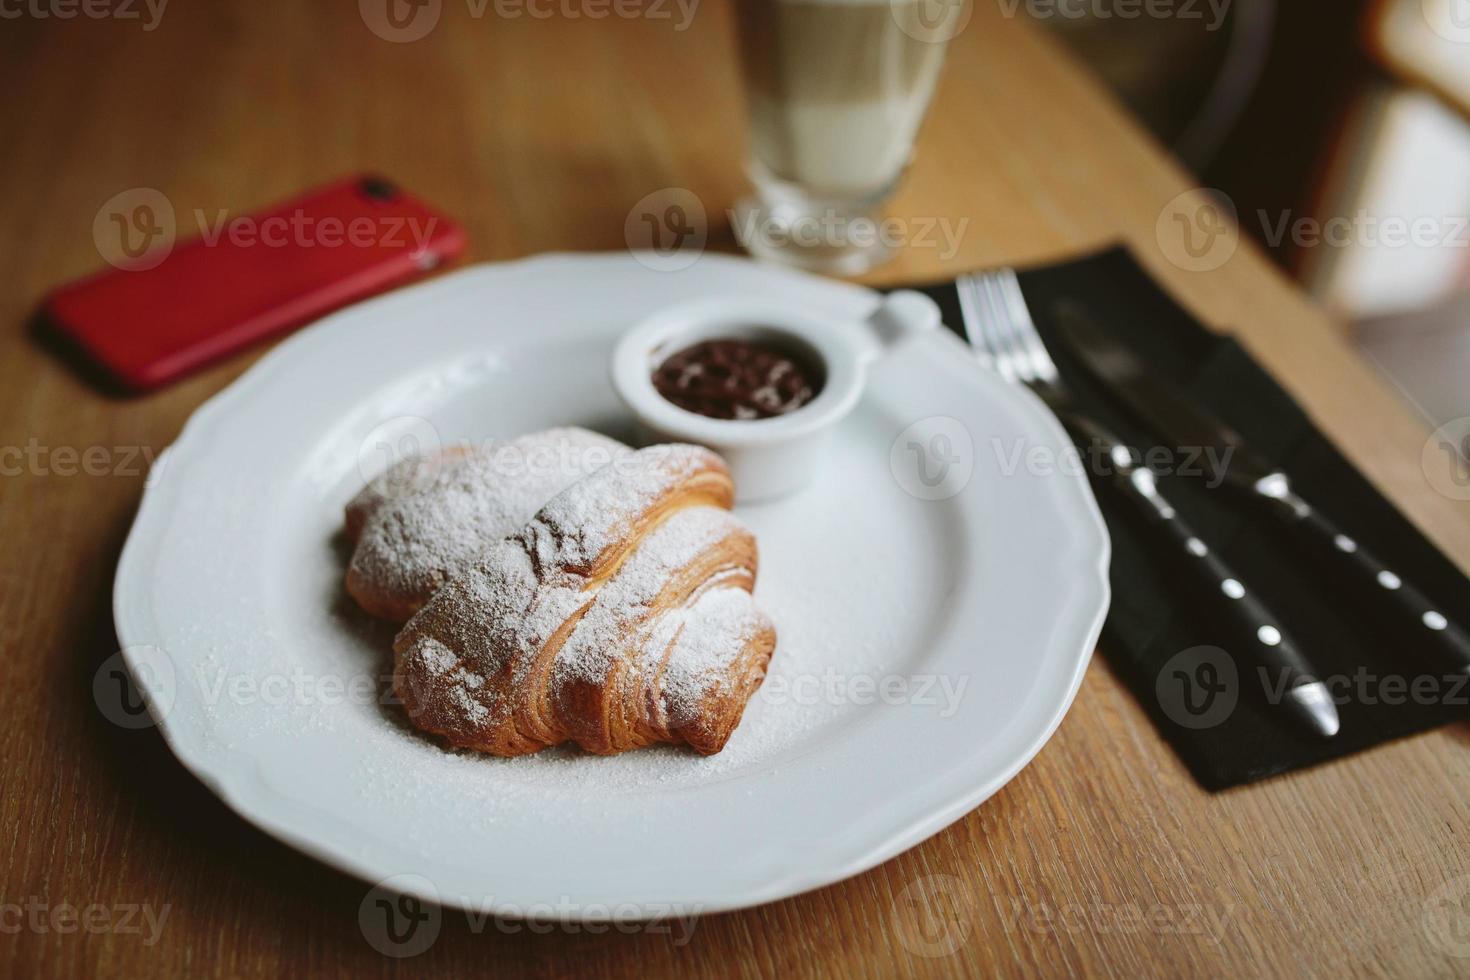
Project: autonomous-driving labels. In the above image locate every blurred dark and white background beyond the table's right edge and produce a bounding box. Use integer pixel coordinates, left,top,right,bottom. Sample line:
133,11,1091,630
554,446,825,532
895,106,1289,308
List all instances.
1020,0,1470,434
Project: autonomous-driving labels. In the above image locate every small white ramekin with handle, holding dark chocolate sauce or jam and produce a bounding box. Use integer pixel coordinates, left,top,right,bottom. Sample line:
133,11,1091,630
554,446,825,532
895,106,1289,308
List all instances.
612,289,939,502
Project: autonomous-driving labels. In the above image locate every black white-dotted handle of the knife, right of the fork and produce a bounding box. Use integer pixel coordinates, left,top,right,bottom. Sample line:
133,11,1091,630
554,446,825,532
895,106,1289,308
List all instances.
1255,473,1470,673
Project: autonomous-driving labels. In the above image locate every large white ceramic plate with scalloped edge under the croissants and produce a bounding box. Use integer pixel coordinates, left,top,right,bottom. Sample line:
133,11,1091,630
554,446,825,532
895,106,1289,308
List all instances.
115,254,1108,918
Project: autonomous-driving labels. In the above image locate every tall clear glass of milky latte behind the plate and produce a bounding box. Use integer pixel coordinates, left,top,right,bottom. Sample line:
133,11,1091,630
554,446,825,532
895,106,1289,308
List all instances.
735,0,964,275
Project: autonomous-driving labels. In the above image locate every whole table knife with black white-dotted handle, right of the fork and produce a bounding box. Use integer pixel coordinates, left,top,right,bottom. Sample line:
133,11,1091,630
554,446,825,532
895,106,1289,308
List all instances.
1053,303,1470,673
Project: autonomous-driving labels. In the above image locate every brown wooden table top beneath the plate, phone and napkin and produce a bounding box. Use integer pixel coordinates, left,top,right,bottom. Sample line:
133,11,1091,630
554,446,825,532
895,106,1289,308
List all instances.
0,0,1470,977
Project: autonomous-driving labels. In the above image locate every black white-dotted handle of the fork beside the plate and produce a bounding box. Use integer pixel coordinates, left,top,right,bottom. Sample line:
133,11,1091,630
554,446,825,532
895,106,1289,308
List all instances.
1117,466,1319,691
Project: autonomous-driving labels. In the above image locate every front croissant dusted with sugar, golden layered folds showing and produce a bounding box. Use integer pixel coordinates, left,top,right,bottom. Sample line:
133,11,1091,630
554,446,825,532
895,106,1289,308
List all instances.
394,445,776,755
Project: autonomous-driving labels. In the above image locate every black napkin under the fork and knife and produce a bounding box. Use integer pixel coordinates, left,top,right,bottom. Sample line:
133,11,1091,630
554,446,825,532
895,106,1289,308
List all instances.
899,248,1470,790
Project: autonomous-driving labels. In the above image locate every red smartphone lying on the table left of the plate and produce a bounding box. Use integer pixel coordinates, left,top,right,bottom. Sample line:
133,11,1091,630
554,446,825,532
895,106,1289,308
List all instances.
43,176,465,391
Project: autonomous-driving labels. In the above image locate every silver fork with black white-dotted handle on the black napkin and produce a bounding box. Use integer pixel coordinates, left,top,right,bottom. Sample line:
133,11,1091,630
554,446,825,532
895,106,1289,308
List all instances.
954,269,1341,738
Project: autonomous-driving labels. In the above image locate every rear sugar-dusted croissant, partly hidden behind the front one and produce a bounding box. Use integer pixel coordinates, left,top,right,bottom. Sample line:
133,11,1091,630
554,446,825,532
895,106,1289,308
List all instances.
345,428,631,623
